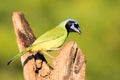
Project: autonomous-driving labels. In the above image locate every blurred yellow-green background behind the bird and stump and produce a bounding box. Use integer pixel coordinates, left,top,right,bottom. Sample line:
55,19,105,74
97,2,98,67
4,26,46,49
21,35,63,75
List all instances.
0,0,120,80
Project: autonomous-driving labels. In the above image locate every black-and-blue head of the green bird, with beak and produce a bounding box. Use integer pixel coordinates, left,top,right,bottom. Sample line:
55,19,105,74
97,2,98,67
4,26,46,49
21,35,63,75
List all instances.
63,19,81,34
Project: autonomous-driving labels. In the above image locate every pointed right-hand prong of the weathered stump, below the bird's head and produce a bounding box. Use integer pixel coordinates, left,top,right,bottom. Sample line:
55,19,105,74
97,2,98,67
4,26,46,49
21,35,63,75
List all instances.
52,41,86,80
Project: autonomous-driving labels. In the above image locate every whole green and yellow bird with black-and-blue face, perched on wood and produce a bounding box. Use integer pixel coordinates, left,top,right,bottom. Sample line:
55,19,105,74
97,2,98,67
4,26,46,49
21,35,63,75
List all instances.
7,18,81,65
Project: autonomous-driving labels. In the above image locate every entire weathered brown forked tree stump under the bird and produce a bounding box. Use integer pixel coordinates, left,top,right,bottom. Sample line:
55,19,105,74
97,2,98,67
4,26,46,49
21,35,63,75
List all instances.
12,12,86,80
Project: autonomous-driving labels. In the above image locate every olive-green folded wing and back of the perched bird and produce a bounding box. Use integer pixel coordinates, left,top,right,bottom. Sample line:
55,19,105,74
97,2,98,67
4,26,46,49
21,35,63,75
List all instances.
33,27,67,45
